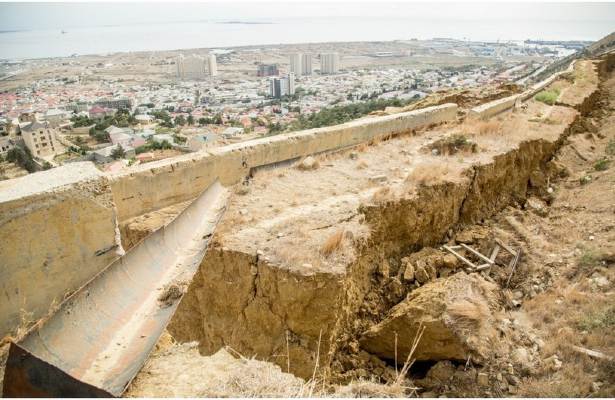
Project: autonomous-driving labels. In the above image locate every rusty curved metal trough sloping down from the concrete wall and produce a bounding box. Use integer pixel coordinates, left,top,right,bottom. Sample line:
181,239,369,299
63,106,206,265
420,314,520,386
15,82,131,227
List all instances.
4,182,228,397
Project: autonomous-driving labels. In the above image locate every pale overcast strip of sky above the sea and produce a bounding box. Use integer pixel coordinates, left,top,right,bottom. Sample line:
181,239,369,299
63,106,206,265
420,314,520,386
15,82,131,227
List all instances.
0,1,615,31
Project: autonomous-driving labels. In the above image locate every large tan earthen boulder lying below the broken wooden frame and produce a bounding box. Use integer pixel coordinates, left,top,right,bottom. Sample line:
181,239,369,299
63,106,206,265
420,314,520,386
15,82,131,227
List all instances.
360,272,499,364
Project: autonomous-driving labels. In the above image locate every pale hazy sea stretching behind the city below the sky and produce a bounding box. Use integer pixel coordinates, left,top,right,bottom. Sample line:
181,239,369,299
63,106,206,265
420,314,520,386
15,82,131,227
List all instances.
0,16,615,60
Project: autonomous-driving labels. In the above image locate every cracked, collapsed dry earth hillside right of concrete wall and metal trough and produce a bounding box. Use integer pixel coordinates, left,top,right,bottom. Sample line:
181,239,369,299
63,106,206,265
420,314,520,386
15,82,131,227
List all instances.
125,55,615,396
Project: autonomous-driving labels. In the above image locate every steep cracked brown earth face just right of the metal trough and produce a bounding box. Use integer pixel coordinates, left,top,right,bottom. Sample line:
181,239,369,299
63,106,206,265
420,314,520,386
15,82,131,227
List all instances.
169,247,341,377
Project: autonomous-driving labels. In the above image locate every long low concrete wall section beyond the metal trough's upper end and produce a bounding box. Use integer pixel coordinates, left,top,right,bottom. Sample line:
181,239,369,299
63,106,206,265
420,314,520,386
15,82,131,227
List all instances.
110,104,457,222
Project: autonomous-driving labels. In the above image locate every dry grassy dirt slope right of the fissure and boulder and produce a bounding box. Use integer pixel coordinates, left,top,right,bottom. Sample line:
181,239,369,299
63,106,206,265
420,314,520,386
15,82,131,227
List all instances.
417,59,615,397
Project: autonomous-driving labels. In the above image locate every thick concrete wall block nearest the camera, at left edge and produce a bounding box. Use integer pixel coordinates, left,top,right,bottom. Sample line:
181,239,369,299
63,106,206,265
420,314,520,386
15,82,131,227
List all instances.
0,163,122,337
